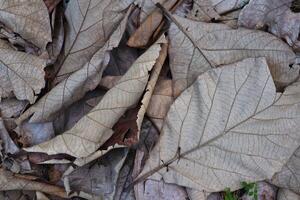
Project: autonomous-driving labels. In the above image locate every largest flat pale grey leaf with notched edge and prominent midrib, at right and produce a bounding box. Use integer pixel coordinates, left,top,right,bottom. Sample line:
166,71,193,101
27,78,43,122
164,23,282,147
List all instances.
137,58,300,192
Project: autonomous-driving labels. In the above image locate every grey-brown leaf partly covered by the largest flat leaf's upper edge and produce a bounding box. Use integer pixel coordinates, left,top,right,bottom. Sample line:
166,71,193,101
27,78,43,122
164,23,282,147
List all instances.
169,16,299,91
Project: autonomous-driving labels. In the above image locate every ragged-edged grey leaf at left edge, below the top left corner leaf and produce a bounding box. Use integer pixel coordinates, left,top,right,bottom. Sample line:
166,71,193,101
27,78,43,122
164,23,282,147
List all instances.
0,40,46,103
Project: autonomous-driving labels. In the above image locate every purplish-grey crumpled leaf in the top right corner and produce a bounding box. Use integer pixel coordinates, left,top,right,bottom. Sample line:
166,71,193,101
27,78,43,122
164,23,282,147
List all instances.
238,0,300,47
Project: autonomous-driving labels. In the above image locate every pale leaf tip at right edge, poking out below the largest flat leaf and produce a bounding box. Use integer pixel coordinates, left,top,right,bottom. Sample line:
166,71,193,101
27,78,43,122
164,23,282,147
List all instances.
272,147,300,194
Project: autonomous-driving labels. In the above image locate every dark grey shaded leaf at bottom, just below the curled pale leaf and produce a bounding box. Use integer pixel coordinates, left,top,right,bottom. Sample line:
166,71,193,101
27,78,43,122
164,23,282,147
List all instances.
66,148,128,199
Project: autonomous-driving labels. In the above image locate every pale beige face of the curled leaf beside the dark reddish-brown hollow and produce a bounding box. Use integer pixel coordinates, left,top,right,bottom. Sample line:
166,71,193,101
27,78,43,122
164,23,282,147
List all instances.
26,39,161,157
